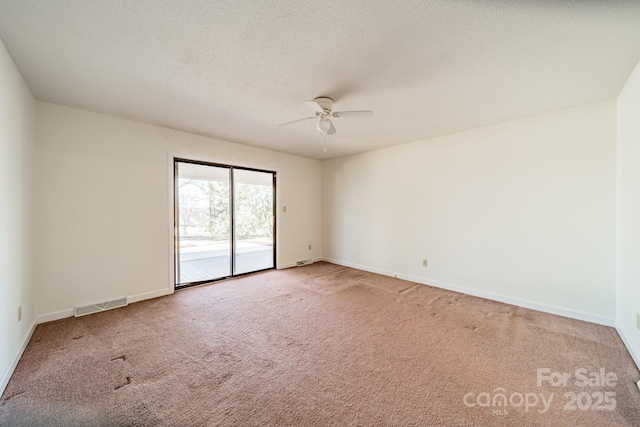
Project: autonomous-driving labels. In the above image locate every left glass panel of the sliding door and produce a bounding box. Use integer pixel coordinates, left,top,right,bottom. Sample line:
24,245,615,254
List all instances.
176,162,232,287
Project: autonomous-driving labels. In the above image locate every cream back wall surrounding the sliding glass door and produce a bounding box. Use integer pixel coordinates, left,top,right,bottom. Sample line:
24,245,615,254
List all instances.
36,102,322,320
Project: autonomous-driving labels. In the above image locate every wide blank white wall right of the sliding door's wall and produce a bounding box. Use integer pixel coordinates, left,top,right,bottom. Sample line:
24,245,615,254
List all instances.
322,100,616,325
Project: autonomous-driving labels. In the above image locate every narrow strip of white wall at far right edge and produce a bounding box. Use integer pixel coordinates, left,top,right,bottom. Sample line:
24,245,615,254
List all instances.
616,60,640,366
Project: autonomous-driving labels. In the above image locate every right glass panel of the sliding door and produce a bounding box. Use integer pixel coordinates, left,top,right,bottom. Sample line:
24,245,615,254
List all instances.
233,169,275,274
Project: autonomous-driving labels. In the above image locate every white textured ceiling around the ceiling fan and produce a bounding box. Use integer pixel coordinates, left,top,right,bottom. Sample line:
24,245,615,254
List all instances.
0,0,640,159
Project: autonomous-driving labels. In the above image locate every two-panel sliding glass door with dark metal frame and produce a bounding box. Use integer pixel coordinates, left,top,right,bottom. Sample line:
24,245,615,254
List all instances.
175,160,275,288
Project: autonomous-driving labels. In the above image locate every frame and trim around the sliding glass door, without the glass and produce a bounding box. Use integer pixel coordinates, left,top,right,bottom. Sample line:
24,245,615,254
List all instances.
168,153,280,293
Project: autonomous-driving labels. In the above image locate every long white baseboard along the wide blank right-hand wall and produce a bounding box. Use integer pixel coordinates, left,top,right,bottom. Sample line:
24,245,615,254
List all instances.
324,258,615,327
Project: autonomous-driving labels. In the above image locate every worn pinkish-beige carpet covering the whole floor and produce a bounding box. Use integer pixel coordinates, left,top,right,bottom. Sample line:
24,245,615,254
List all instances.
0,263,640,426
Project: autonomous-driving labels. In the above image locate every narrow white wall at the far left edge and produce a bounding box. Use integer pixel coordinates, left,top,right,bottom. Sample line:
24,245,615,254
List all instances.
0,38,36,393
